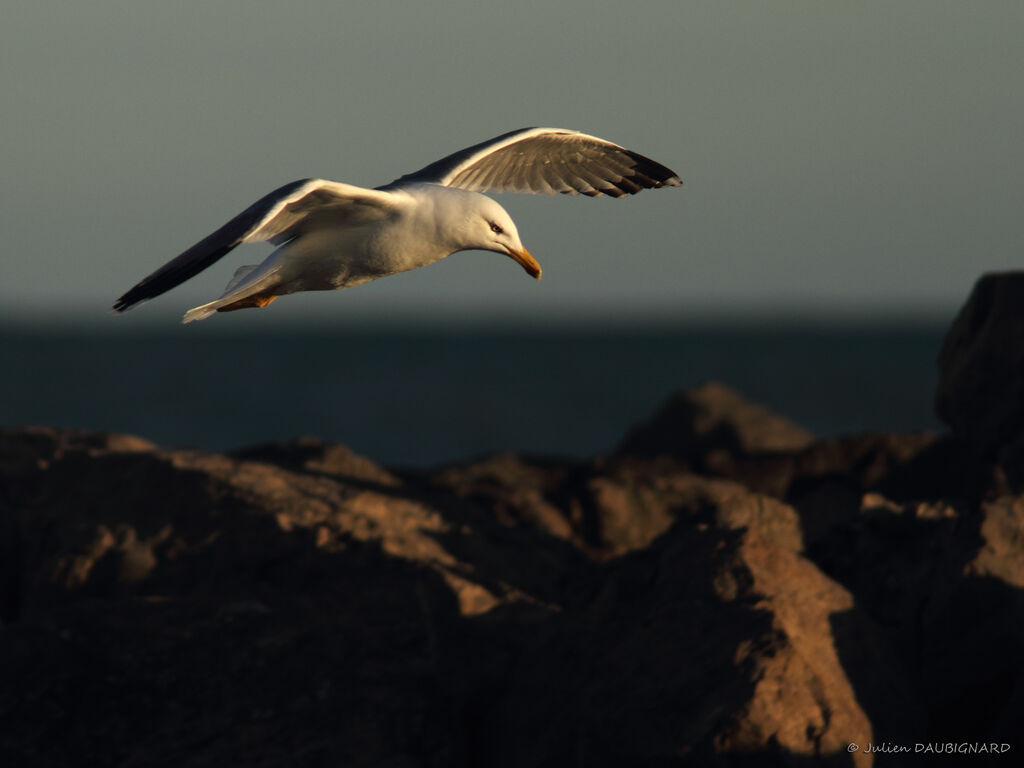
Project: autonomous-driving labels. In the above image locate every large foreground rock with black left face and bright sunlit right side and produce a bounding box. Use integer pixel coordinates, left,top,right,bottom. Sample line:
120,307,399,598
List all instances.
481,478,871,766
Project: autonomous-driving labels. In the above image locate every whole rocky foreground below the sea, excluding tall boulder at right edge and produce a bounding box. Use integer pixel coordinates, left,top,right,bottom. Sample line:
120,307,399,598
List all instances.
0,370,1024,766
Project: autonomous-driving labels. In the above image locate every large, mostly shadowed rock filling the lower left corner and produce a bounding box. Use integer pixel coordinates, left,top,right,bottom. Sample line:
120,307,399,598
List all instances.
0,429,572,765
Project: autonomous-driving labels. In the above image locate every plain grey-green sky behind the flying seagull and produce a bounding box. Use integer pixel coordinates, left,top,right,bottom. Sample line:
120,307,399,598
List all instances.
0,0,1024,324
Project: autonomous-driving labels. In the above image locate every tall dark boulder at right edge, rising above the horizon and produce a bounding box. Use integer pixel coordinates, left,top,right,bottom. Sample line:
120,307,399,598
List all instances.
935,271,1024,455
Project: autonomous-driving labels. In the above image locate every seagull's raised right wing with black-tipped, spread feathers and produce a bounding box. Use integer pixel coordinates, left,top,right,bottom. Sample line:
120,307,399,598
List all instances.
384,128,682,198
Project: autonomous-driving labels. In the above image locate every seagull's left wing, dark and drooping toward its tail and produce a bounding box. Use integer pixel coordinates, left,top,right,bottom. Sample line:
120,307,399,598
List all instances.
114,179,394,312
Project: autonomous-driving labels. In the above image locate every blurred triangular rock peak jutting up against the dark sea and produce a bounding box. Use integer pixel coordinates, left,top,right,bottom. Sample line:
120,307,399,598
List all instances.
616,382,814,459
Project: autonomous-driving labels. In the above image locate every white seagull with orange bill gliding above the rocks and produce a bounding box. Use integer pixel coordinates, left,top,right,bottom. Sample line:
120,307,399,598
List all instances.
114,128,682,323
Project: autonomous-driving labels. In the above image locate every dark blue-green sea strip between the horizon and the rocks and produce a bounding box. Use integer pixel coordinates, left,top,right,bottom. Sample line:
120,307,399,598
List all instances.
0,319,948,466
